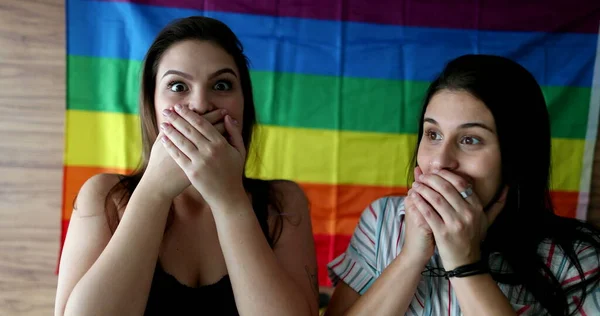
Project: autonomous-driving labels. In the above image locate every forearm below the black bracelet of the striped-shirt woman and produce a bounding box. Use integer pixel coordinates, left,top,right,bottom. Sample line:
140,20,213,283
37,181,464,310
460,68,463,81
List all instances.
450,274,516,315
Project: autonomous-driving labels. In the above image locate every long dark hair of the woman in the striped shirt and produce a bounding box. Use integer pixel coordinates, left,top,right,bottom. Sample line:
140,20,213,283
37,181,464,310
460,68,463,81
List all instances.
408,55,600,316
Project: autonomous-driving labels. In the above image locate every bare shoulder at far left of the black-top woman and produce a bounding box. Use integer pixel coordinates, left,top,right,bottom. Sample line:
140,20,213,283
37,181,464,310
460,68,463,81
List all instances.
73,173,121,217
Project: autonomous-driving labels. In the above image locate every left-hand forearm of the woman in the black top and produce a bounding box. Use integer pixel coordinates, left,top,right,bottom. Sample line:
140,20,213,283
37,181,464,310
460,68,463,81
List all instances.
64,182,171,315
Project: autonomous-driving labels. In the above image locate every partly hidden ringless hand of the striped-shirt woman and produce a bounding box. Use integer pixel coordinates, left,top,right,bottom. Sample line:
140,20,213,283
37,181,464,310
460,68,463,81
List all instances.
402,167,435,265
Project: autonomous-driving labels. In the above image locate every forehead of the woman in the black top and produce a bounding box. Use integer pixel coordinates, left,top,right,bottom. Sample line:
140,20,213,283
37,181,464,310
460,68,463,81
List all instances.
158,40,238,76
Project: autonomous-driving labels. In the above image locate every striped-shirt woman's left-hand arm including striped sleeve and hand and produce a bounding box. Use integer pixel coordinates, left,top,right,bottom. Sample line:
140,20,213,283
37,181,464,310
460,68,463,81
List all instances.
327,190,434,316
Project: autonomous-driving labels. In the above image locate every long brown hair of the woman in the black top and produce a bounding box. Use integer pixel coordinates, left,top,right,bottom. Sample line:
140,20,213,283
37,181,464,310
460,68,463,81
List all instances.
105,16,282,247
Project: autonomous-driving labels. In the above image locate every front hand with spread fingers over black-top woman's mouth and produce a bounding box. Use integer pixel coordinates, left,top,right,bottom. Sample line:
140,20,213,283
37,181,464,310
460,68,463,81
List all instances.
161,105,247,208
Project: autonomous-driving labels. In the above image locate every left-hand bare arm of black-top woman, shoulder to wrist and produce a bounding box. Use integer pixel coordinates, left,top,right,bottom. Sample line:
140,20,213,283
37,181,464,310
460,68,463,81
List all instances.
55,175,171,315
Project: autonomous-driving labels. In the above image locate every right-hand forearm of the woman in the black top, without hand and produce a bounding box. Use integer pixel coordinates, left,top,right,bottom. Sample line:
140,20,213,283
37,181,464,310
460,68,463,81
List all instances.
213,200,317,316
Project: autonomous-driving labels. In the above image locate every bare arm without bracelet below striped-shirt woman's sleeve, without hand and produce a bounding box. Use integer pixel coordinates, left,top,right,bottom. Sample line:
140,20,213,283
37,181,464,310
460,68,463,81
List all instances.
326,252,425,316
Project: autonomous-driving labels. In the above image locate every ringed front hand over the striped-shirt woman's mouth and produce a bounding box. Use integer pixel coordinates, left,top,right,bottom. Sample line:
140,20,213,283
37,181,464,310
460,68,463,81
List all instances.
412,170,508,271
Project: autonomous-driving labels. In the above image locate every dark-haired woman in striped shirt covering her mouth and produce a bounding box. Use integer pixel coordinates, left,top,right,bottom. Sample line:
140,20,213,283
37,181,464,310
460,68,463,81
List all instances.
327,55,600,316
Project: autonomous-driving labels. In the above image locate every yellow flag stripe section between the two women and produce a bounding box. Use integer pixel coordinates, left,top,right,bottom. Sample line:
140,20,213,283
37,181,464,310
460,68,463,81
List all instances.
248,125,416,186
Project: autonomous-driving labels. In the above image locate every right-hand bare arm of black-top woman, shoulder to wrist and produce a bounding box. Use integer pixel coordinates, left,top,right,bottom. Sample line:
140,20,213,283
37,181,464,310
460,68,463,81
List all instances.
213,182,318,316
